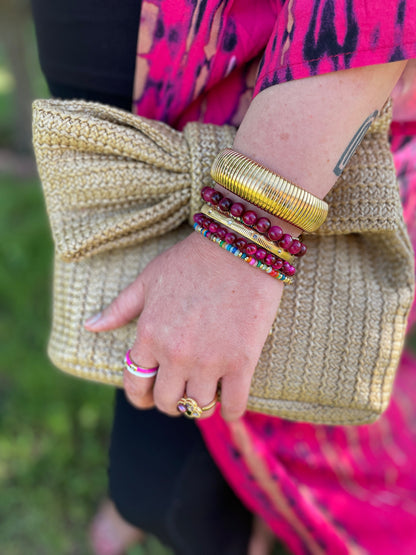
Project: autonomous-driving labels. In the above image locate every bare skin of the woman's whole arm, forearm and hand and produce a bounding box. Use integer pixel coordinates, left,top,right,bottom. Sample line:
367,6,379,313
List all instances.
86,62,406,420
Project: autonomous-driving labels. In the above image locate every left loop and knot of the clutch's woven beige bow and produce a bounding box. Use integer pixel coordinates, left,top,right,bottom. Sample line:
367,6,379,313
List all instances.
33,100,235,261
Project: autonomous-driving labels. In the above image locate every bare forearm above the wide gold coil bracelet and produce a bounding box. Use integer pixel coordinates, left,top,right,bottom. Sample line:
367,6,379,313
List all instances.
214,62,406,238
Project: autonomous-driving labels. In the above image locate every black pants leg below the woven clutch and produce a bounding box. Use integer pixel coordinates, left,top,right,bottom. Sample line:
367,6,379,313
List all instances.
109,390,252,555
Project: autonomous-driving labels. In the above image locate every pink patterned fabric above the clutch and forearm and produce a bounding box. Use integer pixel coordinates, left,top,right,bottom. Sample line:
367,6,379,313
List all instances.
134,0,416,127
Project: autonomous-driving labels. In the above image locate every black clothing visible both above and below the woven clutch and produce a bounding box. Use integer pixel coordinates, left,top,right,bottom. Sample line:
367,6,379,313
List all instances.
32,0,252,555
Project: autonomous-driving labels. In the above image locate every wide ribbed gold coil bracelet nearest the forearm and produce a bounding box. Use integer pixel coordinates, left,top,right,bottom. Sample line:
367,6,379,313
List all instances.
211,148,328,232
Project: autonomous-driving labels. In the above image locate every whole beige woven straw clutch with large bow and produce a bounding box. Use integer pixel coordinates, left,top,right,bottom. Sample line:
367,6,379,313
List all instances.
33,100,414,424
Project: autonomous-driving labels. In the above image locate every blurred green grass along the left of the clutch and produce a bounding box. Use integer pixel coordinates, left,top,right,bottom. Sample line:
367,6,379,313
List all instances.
0,177,172,555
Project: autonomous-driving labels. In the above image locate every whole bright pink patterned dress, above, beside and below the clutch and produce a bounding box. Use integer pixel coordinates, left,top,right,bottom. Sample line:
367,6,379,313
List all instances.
134,0,416,555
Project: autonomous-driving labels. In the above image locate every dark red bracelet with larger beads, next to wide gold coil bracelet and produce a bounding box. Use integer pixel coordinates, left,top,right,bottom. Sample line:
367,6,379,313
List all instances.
201,187,307,257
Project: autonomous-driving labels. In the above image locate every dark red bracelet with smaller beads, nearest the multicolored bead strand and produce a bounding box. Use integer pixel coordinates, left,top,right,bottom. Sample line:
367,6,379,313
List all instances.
194,213,296,277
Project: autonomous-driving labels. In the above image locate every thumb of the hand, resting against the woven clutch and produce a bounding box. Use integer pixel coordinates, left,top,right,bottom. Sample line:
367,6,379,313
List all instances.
84,276,144,332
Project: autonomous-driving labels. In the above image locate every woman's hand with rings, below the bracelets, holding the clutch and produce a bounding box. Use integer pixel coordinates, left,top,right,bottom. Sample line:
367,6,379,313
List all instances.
85,233,283,420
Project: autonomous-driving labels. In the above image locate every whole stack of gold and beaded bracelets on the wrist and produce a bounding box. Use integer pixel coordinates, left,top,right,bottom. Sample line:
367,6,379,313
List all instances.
194,148,328,284
